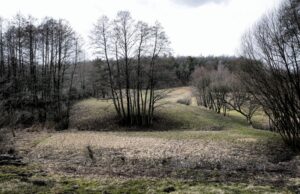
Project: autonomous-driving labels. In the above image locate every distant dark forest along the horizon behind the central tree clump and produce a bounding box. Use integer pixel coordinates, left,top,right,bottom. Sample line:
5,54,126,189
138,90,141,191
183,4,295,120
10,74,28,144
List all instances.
74,56,243,98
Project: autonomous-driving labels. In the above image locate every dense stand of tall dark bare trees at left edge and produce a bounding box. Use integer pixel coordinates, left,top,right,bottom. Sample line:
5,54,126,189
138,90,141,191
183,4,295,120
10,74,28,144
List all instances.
0,14,80,130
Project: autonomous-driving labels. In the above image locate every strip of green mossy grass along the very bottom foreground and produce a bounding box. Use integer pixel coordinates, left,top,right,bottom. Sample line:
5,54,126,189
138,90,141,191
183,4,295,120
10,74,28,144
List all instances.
0,166,292,194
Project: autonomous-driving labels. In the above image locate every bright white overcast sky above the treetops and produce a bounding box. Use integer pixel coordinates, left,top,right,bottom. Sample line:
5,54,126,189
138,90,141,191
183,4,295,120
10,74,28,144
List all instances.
0,0,281,56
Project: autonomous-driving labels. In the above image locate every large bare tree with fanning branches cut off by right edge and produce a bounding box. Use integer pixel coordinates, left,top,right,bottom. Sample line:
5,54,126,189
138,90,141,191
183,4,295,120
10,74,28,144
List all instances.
243,0,300,149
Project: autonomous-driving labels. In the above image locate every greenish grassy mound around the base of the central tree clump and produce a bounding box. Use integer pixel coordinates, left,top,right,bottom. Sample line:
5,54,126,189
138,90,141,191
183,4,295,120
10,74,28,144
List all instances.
71,92,280,141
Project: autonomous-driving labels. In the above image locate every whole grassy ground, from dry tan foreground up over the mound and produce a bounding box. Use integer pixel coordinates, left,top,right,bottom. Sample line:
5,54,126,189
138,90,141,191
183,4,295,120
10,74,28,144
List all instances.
0,88,300,193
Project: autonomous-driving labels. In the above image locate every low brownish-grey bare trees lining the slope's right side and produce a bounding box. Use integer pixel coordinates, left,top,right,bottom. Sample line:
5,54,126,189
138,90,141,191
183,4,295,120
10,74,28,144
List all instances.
192,64,259,125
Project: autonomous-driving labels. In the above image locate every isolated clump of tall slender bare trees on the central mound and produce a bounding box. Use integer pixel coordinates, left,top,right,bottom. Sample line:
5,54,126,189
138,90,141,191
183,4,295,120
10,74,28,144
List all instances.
92,11,169,125
